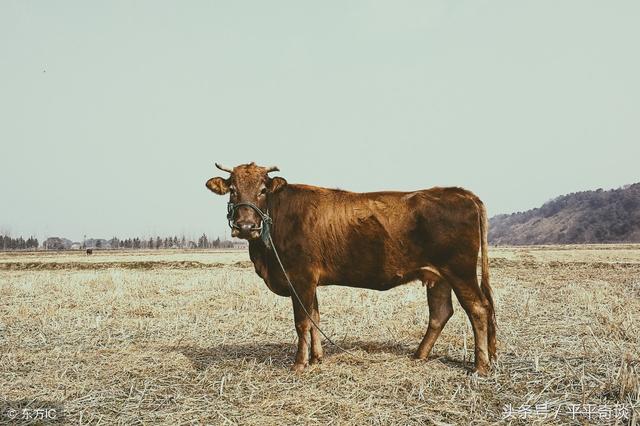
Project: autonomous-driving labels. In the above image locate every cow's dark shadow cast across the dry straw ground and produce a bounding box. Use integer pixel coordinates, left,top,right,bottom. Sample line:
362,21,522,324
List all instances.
164,340,472,370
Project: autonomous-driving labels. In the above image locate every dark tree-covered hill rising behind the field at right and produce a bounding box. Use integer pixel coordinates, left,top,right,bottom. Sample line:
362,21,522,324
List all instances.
489,183,640,245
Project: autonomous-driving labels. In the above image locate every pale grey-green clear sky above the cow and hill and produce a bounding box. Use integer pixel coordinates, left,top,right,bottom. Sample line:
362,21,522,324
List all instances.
0,0,640,240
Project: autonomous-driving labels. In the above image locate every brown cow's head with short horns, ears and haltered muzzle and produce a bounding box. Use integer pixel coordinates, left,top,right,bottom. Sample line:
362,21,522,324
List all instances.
206,163,287,240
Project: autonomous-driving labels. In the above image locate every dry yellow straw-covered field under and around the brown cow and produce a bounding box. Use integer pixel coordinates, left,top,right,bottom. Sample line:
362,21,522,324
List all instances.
0,245,640,425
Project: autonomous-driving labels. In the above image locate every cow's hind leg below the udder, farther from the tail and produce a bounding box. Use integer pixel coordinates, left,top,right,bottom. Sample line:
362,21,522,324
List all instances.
413,281,453,359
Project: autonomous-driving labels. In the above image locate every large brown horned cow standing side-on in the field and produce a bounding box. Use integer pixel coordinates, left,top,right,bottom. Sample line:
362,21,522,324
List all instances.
206,163,496,375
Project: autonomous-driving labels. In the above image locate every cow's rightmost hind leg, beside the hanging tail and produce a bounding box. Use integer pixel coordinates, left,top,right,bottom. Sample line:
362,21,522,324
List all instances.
446,272,490,376
